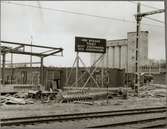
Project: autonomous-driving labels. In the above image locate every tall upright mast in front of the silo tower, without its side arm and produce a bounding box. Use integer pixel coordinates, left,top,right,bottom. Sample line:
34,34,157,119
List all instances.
135,3,142,96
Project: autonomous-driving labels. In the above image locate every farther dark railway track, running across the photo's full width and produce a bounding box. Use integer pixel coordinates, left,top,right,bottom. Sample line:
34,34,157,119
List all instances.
0,107,167,128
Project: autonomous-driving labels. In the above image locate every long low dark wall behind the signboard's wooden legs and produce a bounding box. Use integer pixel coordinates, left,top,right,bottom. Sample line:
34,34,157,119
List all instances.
4,67,125,90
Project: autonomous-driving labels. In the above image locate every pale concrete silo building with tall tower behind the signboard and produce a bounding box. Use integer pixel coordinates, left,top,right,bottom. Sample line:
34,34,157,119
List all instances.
91,31,148,72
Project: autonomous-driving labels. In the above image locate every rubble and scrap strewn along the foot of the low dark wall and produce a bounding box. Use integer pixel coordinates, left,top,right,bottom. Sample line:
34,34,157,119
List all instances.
0,84,166,105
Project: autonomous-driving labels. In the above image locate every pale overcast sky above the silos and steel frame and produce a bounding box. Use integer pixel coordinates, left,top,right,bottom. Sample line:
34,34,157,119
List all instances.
1,1,165,66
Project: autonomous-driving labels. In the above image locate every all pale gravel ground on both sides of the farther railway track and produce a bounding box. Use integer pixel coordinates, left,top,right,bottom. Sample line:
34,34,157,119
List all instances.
0,84,166,129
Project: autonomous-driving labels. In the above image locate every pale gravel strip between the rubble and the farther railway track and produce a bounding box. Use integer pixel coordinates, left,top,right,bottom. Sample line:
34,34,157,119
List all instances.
0,97,166,118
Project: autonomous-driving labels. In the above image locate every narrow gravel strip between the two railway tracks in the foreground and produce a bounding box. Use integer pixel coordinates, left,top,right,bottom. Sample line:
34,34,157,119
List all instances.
1,113,164,129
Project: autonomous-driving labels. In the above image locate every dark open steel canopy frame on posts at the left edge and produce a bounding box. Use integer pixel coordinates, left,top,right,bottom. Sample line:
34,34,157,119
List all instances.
0,41,63,85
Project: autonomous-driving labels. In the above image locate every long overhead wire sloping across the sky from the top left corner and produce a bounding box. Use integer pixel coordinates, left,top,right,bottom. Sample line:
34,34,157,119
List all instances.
3,2,164,28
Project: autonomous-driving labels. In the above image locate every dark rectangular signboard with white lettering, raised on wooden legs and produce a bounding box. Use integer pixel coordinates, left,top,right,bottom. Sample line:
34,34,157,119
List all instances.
75,37,106,53
